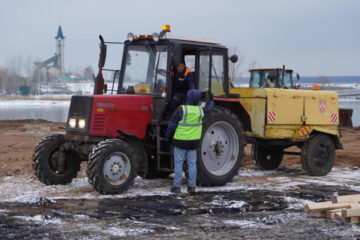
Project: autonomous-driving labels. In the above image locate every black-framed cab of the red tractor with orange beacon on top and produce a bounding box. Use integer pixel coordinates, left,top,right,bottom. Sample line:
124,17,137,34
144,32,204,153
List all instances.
94,25,236,122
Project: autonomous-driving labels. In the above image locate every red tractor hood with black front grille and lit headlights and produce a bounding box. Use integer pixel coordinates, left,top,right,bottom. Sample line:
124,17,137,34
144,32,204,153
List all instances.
67,94,153,139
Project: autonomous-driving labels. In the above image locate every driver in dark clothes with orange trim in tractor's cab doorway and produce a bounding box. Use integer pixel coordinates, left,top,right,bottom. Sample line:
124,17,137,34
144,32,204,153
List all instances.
169,61,195,113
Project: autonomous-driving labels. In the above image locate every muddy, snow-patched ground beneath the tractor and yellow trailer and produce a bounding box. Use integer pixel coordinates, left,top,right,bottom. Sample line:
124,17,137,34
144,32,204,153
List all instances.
0,120,360,239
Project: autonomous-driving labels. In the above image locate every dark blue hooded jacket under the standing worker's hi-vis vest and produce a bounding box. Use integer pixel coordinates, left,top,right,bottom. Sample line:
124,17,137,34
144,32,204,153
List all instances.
166,89,215,149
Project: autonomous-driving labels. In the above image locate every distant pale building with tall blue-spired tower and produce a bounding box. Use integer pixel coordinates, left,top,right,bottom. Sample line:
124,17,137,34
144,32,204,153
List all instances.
34,25,65,82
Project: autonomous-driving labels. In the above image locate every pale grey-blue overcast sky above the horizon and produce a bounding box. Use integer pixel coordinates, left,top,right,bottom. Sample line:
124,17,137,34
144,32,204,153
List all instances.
0,0,360,76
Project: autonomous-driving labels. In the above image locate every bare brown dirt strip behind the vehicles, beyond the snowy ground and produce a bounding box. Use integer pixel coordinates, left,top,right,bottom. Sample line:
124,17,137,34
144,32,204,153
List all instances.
0,120,360,177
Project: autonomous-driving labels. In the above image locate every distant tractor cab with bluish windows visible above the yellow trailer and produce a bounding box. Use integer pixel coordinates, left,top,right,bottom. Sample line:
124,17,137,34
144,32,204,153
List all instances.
249,67,299,88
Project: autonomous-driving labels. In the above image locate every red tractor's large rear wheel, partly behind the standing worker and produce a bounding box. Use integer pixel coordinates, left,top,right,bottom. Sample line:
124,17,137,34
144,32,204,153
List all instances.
197,107,245,186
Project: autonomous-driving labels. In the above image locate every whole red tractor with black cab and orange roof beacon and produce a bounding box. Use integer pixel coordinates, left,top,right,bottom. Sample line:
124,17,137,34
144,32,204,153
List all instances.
32,25,246,194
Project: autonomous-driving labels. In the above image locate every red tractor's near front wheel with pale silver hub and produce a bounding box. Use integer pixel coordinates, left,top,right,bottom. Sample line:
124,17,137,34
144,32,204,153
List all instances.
86,139,136,194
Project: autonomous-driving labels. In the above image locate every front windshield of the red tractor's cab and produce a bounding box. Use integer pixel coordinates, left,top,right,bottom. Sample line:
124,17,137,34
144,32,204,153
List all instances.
119,45,168,94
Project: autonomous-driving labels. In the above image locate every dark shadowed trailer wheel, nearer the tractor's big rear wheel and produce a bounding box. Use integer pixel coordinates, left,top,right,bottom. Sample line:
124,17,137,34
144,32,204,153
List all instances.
251,143,284,170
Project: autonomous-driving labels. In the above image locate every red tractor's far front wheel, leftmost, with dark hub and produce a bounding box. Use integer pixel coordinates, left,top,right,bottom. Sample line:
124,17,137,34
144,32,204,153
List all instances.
32,134,81,185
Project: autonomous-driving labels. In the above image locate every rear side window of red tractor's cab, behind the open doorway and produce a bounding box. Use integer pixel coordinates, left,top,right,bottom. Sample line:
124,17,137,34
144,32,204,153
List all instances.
197,49,227,97
